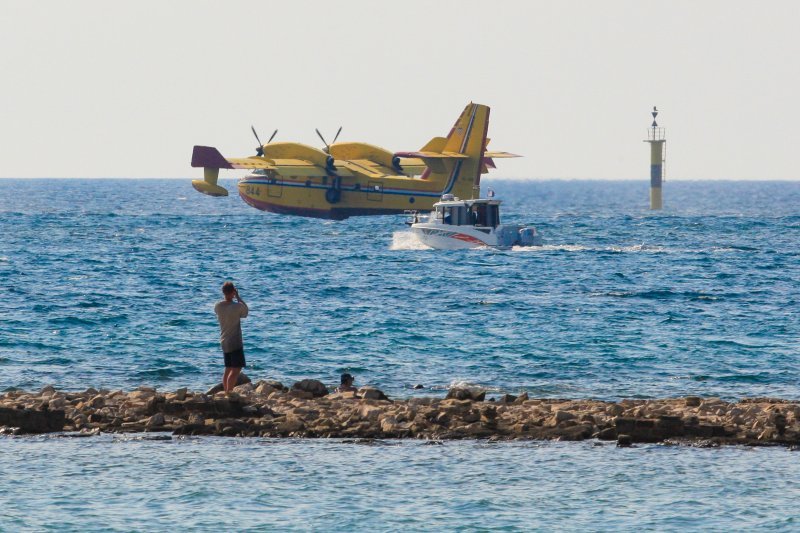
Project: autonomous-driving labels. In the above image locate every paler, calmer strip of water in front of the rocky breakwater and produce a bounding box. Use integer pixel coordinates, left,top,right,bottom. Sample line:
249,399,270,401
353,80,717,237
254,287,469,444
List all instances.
0,436,800,531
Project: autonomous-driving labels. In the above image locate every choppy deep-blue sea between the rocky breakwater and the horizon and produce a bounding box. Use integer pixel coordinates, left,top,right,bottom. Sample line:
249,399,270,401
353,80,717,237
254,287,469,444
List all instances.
0,180,800,399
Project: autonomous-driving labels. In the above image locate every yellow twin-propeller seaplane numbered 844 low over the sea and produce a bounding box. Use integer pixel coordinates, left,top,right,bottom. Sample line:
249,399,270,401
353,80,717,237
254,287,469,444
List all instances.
191,103,520,220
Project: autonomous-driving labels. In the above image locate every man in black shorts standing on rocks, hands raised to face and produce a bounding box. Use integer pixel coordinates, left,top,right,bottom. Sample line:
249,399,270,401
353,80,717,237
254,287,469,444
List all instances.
214,281,249,392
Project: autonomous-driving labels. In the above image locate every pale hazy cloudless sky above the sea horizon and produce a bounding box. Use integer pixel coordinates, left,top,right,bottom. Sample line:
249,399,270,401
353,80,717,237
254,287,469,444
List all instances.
0,0,800,180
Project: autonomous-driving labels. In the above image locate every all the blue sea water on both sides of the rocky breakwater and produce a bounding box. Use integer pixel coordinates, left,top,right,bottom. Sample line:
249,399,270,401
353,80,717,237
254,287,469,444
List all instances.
0,179,800,530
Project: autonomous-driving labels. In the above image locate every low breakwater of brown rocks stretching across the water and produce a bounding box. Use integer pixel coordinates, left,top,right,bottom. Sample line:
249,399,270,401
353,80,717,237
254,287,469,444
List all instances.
0,380,800,446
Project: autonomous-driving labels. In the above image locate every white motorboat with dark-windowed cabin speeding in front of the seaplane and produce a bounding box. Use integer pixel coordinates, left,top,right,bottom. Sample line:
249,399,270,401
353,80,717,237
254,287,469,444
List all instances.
407,193,542,250
